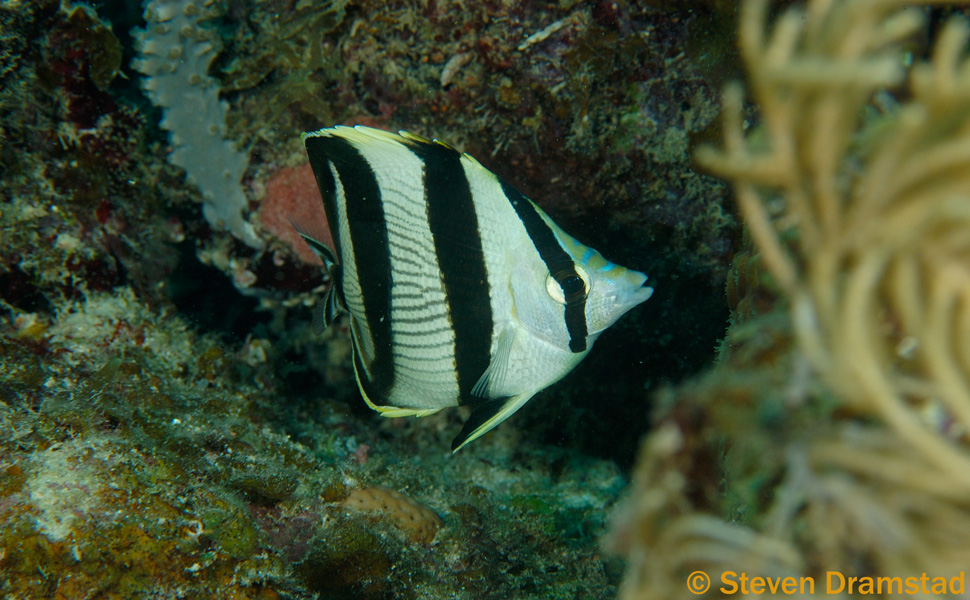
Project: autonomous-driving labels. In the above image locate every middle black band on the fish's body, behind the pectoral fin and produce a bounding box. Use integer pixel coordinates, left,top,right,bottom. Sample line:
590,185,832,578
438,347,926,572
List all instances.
411,144,493,403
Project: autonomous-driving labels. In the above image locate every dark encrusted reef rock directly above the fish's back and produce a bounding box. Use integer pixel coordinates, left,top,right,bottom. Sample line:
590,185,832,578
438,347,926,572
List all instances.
223,0,734,277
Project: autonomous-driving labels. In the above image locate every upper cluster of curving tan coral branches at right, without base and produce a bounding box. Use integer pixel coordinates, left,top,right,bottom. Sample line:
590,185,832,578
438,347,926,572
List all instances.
698,0,970,478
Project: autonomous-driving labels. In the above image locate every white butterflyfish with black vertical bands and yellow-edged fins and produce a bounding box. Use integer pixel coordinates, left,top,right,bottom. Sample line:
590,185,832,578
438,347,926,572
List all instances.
294,125,653,452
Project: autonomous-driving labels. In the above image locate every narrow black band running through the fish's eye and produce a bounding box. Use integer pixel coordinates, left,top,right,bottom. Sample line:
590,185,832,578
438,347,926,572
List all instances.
501,180,589,353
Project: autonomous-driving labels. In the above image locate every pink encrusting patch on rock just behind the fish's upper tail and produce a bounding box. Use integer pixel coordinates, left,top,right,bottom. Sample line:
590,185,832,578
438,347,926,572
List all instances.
259,164,333,265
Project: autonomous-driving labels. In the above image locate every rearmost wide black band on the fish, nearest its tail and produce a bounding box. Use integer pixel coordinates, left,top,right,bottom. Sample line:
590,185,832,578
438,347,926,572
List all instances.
307,137,394,397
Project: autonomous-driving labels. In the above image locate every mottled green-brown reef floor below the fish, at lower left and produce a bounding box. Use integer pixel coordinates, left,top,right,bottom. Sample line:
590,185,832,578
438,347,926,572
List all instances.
0,288,623,599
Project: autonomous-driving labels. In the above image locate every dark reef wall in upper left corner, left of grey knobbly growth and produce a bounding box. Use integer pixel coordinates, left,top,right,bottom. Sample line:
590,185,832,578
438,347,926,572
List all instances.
0,1,180,313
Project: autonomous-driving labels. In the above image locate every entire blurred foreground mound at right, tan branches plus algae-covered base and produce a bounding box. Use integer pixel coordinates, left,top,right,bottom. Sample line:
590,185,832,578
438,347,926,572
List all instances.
609,0,970,600
